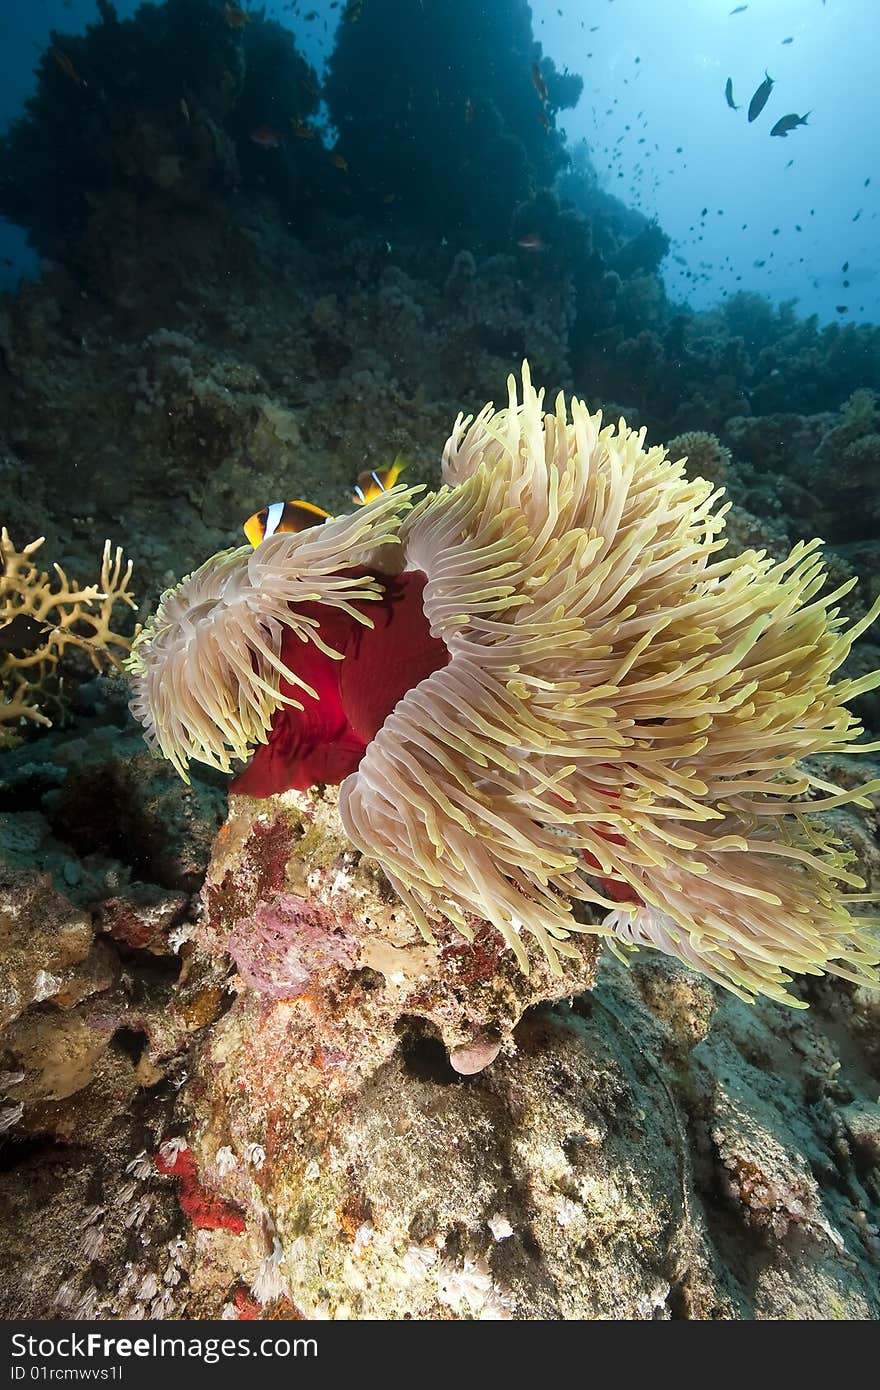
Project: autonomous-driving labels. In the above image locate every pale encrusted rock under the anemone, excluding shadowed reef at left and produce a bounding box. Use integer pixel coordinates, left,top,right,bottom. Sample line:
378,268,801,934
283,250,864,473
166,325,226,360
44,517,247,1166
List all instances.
98,788,880,1319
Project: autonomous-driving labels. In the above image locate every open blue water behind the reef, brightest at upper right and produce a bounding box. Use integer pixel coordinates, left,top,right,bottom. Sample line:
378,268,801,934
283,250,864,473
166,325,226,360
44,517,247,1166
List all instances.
0,0,880,322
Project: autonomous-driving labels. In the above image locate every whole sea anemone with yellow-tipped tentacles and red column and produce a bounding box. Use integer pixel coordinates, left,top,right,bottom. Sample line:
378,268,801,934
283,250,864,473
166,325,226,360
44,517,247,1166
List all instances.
132,364,880,1002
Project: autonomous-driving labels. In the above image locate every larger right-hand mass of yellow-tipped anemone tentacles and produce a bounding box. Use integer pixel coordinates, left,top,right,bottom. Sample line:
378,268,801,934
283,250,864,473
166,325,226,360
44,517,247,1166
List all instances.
341,370,880,999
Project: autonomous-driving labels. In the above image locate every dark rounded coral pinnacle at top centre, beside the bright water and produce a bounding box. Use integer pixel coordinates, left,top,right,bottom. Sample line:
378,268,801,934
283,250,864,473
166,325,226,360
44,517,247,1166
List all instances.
324,0,582,239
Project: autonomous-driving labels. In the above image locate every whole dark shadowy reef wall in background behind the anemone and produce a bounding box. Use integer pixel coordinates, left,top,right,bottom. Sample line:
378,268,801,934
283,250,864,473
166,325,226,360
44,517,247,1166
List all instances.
0,0,880,706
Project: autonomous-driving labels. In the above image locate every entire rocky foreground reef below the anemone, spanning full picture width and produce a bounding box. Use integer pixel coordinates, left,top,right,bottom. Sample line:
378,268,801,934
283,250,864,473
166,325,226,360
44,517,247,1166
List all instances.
0,756,880,1319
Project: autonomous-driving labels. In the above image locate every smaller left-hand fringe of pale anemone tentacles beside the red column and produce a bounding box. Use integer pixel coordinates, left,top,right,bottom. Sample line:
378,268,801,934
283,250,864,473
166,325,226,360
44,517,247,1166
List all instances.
127,487,418,781
